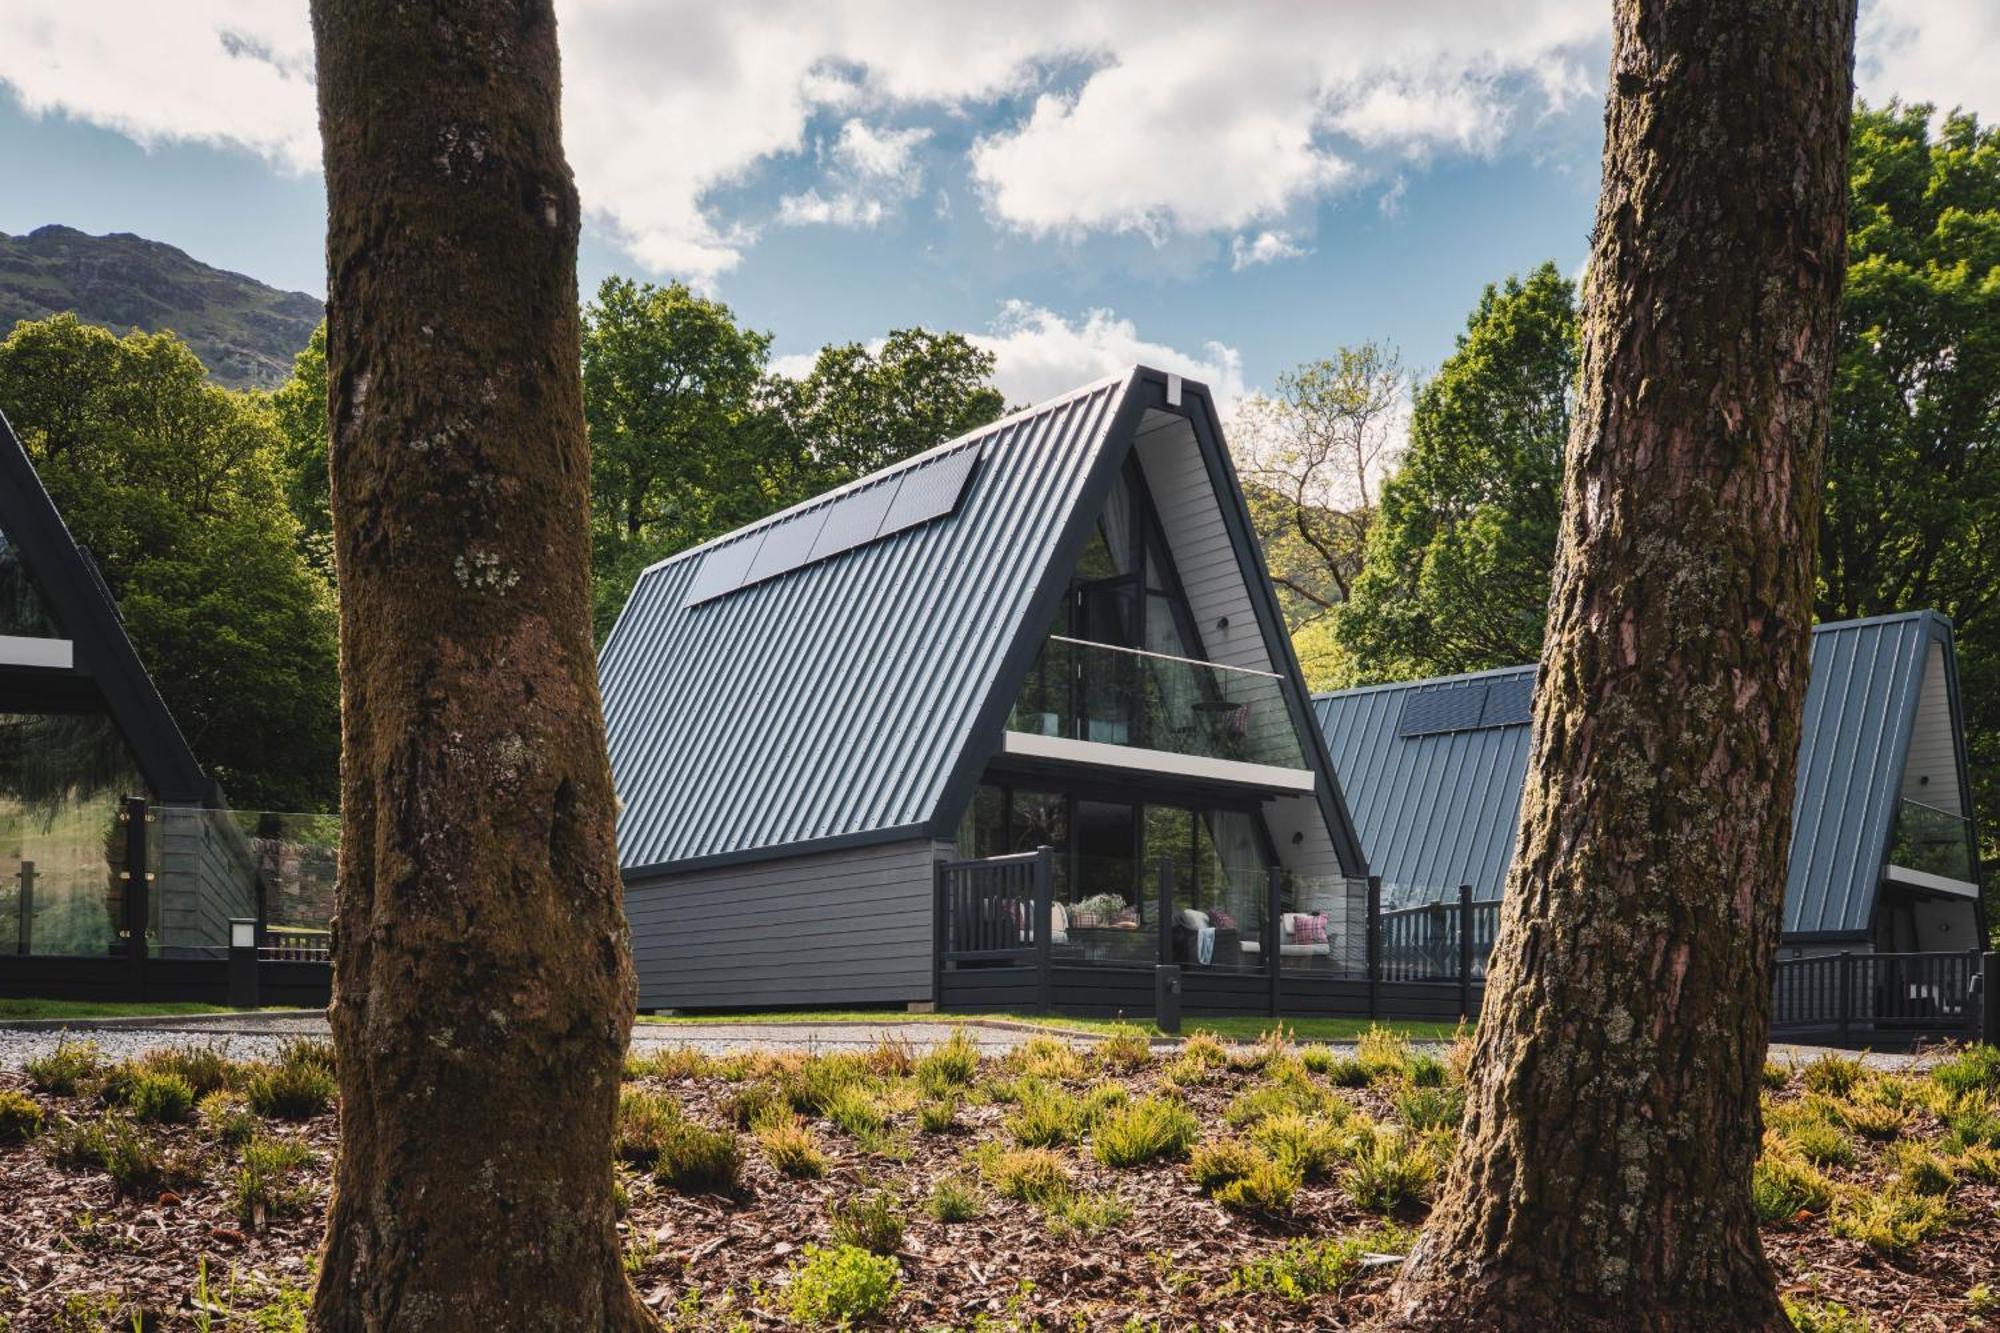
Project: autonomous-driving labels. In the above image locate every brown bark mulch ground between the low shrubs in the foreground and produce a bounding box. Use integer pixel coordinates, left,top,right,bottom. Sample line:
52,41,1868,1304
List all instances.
0,1049,2000,1333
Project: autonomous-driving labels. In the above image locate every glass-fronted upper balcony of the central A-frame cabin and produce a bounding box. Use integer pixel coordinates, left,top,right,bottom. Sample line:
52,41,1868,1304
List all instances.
1008,634,1306,785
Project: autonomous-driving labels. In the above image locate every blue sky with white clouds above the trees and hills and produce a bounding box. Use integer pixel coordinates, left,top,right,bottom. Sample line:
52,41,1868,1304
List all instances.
0,0,2000,402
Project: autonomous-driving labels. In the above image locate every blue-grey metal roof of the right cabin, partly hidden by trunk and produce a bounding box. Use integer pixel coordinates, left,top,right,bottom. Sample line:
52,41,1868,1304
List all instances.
1314,610,1964,939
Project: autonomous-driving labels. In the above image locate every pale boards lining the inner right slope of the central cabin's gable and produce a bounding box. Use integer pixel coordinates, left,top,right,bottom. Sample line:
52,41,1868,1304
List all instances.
1134,410,1366,888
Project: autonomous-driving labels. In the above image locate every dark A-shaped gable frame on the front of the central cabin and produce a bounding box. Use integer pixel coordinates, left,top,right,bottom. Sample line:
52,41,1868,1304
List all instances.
926,366,1366,877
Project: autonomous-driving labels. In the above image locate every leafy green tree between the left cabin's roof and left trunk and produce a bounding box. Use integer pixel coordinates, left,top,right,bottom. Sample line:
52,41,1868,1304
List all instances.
0,314,340,811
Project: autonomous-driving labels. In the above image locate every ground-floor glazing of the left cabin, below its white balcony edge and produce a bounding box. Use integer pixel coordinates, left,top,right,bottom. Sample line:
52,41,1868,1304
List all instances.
0,713,144,957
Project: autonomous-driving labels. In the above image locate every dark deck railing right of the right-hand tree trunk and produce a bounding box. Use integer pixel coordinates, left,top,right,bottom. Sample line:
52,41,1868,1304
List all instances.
1770,949,1982,1037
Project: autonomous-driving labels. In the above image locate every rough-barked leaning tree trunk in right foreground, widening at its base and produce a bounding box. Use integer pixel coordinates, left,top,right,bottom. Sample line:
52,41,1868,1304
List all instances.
1386,0,1854,1331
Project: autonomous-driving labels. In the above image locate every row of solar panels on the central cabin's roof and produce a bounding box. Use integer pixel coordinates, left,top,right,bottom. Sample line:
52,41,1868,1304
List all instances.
682,442,980,606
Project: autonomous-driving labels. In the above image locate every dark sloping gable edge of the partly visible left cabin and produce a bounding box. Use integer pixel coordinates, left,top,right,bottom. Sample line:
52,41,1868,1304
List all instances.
0,416,218,805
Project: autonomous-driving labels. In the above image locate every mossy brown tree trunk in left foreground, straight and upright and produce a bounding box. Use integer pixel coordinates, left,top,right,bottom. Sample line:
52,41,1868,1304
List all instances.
312,0,654,1333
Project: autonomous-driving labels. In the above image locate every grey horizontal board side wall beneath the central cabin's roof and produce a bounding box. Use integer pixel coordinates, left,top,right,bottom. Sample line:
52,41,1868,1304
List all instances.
626,841,934,1009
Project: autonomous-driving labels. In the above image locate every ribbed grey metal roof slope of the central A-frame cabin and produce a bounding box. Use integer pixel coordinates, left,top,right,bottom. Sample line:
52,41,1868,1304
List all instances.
598,376,1134,877
